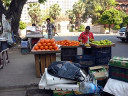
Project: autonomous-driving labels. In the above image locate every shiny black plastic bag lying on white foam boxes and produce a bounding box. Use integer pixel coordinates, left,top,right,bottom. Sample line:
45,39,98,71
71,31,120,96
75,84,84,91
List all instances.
48,61,84,81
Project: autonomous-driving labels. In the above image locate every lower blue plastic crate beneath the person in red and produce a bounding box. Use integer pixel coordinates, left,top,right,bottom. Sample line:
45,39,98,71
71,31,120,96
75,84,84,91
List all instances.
76,55,95,67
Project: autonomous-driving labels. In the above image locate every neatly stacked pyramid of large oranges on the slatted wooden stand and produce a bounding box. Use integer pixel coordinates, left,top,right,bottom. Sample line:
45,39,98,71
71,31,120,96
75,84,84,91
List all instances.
33,39,59,51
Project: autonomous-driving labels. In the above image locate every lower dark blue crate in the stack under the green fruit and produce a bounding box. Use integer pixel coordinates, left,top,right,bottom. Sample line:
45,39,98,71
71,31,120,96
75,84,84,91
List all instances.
95,54,111,66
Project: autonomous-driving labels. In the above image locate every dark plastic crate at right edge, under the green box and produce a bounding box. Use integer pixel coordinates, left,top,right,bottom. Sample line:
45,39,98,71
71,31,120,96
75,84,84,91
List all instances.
109,65,128,82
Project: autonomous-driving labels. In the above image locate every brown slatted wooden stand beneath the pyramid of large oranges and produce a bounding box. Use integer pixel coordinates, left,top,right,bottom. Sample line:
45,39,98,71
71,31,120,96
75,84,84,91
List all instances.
31,50,61,78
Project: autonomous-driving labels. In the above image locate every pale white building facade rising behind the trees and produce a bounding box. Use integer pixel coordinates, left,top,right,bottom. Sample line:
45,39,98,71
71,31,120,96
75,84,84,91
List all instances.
21,0,78,23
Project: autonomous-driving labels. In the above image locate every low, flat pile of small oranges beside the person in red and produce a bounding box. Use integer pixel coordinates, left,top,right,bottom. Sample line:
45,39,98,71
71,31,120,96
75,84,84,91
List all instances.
56,39,81,46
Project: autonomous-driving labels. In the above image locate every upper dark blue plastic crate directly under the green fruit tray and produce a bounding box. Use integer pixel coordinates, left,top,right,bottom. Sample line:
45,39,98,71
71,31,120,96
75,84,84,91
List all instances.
91,47,111,58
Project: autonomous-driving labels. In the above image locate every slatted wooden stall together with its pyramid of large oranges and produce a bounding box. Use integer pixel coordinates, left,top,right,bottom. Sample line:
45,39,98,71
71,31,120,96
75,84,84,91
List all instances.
31,39,61,77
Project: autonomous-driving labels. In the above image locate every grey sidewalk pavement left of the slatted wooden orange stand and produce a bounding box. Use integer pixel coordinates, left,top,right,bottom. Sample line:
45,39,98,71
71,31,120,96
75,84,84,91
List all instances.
0,48,60,90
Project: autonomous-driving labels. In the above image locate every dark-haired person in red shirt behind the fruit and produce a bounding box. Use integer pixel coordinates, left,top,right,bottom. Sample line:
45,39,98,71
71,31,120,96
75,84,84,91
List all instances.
78,26,94,44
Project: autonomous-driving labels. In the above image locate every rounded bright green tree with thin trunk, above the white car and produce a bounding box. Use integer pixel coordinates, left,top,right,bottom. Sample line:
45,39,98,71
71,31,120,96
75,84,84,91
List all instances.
100,9,123,32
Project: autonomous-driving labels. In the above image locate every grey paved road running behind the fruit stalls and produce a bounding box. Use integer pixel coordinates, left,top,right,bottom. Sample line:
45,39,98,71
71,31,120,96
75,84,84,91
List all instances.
55,35,128,57
